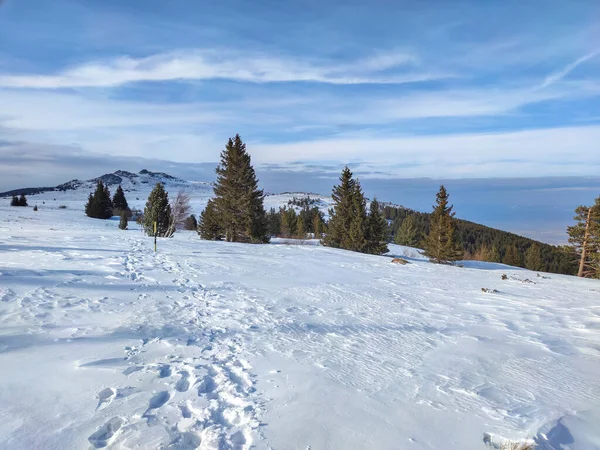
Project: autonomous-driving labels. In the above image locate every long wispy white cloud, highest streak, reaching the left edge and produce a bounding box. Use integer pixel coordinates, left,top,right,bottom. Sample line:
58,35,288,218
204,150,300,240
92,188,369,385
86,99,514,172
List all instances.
0,50,440,89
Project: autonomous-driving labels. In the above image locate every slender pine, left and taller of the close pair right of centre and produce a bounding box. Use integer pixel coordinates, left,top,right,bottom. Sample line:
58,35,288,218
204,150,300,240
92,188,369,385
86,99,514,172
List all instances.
323,167,356,249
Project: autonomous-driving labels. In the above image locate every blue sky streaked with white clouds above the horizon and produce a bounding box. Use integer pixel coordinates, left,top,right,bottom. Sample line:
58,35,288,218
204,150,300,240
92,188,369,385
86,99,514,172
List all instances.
0,0,600,243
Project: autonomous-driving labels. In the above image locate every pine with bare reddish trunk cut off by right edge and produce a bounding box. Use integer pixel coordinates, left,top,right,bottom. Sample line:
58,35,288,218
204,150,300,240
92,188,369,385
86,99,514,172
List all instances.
567,197,600,277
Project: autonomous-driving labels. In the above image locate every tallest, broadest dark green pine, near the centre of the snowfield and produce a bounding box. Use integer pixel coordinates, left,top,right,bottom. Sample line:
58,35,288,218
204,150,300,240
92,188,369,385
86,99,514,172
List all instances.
209,134,269,243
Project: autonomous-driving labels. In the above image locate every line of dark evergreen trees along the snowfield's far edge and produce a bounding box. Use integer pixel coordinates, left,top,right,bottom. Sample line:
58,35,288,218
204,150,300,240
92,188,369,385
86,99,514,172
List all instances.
78,135,600,277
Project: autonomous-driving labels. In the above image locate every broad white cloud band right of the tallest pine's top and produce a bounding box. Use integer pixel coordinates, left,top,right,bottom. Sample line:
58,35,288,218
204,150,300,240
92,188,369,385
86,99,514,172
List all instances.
250,126,600,178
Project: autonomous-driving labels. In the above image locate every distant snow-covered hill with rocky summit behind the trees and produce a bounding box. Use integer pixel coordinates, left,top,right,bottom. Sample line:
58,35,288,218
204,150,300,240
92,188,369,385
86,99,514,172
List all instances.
0,170,332,215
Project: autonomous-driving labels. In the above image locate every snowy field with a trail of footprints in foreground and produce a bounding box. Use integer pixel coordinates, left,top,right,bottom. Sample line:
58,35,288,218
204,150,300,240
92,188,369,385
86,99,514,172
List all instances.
0,204,600,450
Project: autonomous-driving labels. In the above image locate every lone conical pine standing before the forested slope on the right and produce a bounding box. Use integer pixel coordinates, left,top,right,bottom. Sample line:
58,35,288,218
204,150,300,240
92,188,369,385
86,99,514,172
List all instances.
423,185,463,264
